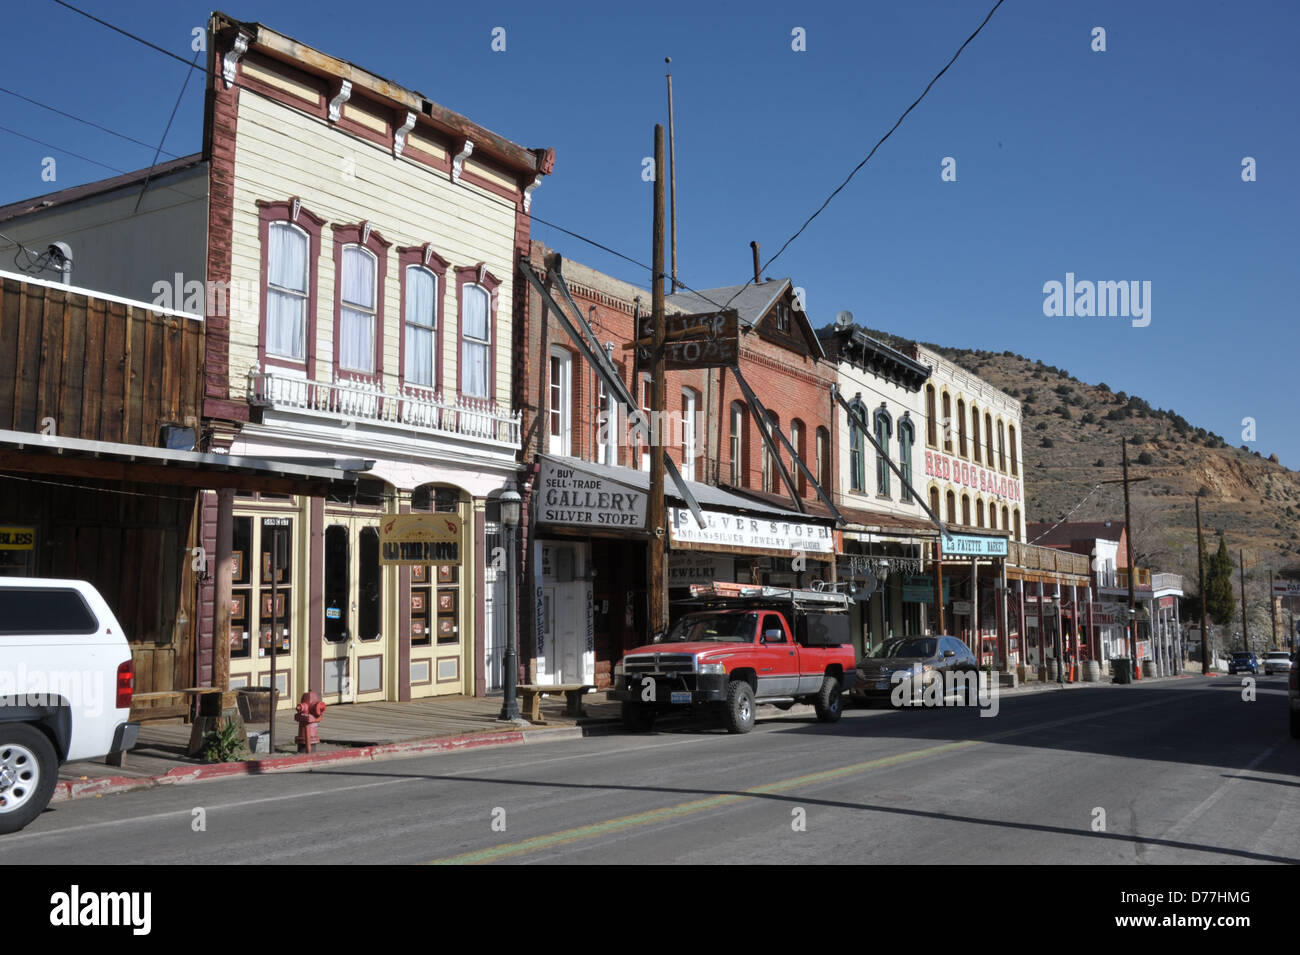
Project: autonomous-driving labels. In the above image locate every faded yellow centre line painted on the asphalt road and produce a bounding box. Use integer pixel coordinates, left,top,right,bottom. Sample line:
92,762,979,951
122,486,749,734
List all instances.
428,739,985,865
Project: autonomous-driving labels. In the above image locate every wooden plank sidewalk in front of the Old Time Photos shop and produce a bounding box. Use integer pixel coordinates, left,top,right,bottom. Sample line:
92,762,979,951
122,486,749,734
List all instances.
52,691,619,802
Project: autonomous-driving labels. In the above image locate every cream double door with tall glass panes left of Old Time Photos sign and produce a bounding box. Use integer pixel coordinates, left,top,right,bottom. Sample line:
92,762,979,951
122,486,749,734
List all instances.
322,512,389,703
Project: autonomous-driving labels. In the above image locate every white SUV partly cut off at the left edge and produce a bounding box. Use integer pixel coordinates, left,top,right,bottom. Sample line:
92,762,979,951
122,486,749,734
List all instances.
0,577,139,833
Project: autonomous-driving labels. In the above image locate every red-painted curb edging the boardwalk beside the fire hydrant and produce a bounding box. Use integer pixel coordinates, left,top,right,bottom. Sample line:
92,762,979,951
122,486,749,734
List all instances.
49,725,602,804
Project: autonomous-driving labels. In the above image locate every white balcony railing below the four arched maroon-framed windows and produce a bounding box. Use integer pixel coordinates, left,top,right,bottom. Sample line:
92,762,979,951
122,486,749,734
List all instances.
248,370,520,450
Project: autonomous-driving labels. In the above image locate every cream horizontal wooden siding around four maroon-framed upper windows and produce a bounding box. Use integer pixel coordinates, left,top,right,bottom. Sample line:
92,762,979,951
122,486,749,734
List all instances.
230,90,516,408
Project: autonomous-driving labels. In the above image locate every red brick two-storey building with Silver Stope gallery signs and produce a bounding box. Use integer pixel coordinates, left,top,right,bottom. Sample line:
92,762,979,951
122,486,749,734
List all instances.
515,242,836,686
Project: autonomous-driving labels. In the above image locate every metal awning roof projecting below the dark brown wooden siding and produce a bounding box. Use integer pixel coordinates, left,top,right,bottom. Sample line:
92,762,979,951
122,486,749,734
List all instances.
0,430,374,498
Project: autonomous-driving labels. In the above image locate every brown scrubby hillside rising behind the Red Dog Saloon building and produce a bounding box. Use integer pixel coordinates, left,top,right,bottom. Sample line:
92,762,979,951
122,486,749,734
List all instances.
852,330,1300,603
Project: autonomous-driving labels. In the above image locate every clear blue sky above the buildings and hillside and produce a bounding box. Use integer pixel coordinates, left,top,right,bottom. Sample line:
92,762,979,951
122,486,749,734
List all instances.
0,0,1300,468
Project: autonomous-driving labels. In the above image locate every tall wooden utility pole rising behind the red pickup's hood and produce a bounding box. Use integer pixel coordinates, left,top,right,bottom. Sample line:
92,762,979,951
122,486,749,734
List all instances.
646,123,668,633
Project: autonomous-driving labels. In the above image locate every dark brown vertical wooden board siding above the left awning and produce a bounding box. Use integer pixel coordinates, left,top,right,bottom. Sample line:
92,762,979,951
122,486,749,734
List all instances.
0,277,203,447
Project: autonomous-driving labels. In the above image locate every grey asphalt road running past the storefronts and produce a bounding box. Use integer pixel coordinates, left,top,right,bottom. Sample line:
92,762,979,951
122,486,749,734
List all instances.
0,677,1300,865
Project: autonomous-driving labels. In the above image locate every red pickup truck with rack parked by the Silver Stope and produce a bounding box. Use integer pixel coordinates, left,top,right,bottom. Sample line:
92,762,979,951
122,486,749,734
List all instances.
608,587,857,733
